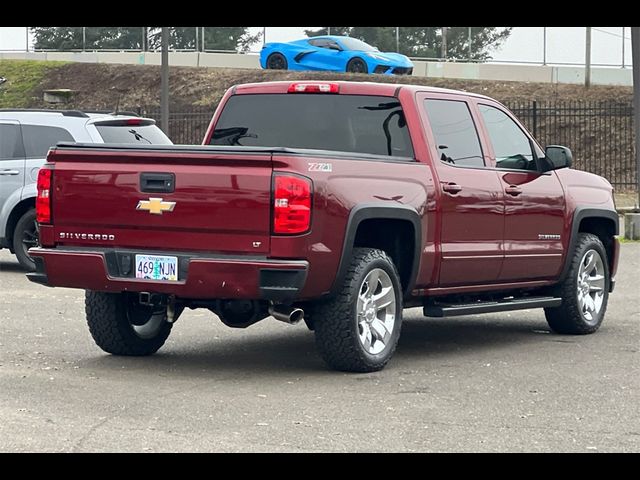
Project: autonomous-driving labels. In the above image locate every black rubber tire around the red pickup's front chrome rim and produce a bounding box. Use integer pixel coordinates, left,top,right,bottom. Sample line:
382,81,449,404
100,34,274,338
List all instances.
544,233,610,335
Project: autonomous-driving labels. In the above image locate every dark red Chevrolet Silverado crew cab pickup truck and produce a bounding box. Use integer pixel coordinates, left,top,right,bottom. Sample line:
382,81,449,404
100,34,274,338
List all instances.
29,82,619,372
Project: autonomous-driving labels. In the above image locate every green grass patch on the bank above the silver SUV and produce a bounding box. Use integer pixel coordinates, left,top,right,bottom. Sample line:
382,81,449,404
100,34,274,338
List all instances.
0,60,67,108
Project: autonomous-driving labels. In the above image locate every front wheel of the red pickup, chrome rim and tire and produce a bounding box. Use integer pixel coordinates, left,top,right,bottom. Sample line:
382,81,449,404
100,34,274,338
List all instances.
545,233,610,335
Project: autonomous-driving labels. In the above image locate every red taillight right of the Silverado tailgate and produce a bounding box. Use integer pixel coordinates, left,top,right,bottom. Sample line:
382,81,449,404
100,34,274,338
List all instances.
273,174,313,235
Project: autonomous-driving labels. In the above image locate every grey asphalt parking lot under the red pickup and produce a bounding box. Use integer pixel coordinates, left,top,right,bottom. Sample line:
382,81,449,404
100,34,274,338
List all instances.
0,243,640,452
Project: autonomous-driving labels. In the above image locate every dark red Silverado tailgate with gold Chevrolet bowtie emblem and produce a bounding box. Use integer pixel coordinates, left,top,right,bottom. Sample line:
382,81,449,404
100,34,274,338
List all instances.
48,146,272,254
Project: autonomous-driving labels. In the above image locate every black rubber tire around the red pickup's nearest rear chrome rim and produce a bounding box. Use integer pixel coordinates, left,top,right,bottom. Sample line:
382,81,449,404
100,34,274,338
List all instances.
313,248,402,373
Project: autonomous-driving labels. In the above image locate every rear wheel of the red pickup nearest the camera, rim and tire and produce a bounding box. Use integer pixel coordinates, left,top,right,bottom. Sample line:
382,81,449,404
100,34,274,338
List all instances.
313,248,402,372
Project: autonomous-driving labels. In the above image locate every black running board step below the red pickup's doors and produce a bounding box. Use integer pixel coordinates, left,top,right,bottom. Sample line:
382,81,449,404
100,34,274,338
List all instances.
424,297,562,318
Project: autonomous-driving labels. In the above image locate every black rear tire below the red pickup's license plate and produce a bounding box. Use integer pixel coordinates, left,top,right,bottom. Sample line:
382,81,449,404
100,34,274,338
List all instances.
85,290,173,356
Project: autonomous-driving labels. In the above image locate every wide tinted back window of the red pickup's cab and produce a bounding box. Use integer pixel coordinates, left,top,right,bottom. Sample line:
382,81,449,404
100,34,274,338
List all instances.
210,94,413,158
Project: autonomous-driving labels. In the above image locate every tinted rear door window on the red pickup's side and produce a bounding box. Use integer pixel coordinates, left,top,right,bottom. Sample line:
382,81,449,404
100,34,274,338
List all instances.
424,100,484,167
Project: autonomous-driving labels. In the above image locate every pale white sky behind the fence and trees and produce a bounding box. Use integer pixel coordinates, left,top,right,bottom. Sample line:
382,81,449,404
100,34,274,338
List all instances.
0,27,631,66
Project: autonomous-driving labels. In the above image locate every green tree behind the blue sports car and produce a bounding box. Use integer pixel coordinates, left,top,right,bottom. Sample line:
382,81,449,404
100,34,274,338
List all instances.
305,27,511,61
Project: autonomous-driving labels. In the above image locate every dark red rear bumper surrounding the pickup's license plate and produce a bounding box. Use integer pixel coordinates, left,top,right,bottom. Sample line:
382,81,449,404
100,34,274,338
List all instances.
27,248,309,301
